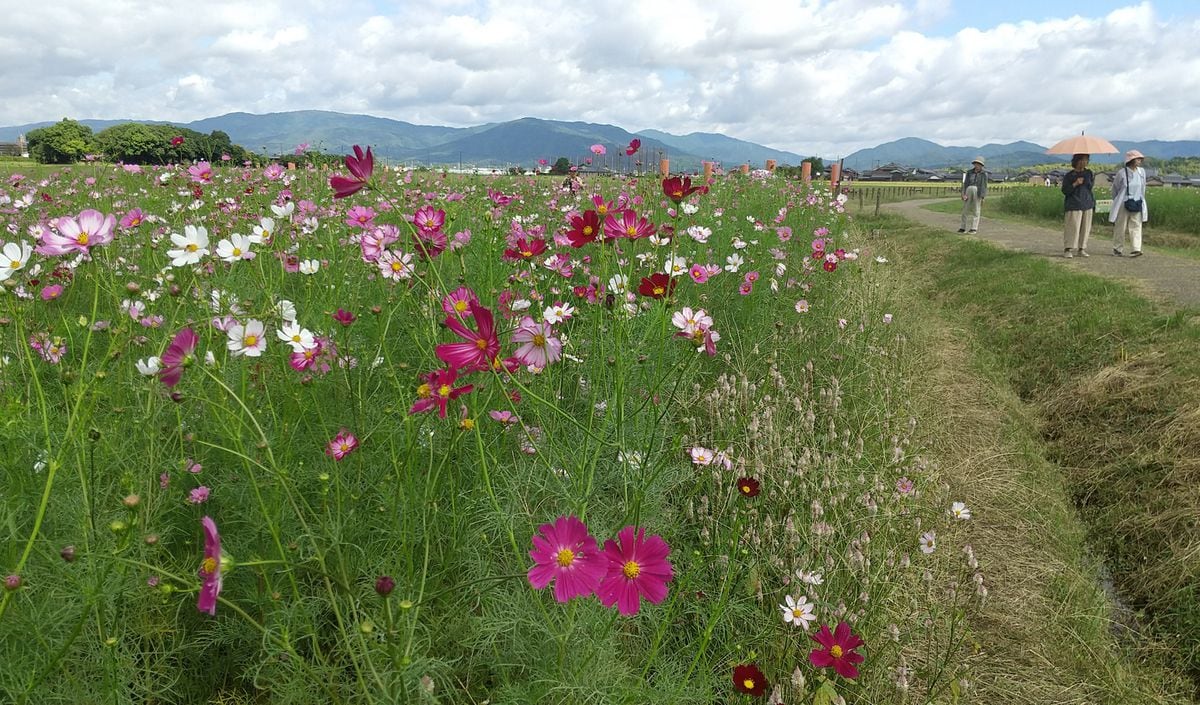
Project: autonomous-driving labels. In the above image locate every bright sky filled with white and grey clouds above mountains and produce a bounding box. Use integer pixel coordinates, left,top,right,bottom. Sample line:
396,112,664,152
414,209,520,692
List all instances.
0,0,1200,157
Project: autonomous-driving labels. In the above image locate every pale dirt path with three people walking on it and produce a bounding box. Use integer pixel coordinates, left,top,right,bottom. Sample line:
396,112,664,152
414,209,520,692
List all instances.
883,199,1200,307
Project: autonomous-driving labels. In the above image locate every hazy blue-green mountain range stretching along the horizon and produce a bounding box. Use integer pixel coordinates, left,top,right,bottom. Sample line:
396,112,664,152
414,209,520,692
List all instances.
0,110,1200,170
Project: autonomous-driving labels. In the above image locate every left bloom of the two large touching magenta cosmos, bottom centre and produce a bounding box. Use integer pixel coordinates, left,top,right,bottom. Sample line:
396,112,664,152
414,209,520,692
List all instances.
529,517,608,602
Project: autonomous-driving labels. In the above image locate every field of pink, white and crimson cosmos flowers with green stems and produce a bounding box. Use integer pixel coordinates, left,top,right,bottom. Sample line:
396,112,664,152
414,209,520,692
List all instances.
0,145,986,704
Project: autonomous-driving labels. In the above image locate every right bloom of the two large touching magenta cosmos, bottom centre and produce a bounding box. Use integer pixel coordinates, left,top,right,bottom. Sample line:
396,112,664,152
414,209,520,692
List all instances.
596,526,674,615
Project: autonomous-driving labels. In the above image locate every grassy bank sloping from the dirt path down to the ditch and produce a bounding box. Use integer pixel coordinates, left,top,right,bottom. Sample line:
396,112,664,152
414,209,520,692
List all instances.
864,217,1200,700
